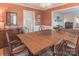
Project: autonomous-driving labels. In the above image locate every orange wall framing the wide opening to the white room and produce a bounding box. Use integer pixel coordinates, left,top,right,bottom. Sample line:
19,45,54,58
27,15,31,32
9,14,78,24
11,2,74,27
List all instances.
43,3,79,25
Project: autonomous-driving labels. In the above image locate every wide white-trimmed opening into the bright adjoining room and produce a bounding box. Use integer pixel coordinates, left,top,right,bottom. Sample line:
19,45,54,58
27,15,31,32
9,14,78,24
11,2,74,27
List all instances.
52,8,79,29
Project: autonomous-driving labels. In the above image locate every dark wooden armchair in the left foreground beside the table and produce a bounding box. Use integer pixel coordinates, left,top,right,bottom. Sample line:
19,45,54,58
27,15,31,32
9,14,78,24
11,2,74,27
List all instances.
6,32,29,56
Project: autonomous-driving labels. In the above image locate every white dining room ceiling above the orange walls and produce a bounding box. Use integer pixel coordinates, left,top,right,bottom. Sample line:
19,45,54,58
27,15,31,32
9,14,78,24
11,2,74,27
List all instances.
14,3,65,10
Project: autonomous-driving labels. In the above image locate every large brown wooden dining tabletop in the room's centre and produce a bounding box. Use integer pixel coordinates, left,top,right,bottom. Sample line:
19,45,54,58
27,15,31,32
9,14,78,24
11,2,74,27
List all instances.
17,30,78,55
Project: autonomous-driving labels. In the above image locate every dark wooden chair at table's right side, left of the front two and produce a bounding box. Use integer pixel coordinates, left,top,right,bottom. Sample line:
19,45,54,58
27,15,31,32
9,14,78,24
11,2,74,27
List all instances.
54,39,66,56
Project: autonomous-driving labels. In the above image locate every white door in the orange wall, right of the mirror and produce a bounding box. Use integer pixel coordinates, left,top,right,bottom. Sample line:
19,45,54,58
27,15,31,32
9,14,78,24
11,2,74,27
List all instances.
23,10,35,32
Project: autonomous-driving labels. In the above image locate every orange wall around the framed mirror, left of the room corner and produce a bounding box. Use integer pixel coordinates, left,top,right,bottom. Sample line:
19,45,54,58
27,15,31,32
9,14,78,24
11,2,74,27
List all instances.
0,3,41,29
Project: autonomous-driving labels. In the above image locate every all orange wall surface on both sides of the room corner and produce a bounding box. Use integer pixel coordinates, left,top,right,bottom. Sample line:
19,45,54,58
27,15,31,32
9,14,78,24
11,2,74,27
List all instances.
0,3,79,28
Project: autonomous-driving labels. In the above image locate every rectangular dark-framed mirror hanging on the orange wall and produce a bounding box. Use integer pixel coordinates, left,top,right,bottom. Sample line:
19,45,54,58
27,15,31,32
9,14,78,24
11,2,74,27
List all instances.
6,12,17,25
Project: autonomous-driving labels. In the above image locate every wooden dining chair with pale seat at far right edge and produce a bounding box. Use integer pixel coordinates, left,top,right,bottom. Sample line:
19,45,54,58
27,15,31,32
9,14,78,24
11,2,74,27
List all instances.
63,33,79,56
